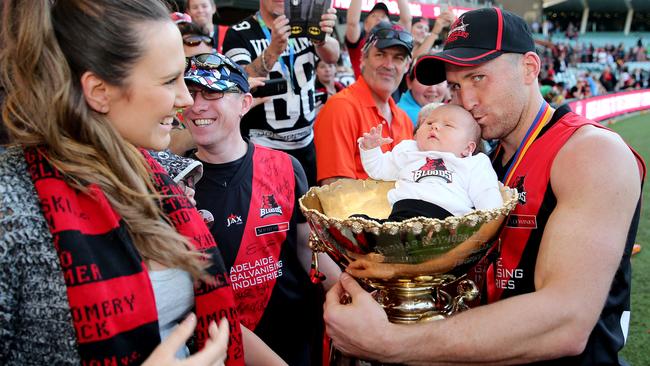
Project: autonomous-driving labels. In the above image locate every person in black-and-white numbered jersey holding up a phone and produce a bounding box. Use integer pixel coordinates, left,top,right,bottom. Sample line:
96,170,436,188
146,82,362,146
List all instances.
223,0,339,185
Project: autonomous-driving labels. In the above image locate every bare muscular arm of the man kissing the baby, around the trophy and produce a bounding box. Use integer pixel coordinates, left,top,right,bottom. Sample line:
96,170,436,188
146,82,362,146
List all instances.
325,127,640,365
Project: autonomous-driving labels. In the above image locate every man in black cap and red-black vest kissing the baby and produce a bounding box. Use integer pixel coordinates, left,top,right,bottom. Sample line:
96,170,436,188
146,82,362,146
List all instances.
325,8,645,365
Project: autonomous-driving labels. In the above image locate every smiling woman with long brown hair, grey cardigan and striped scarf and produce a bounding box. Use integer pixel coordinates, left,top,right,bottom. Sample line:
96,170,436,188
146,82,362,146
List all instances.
0,0,284,365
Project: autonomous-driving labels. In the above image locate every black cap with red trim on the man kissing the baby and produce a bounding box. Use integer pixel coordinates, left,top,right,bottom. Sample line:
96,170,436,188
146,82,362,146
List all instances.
414,8,535,85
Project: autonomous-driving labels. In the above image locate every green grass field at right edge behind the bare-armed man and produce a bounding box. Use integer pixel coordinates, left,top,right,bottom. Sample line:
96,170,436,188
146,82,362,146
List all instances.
609,113,650,366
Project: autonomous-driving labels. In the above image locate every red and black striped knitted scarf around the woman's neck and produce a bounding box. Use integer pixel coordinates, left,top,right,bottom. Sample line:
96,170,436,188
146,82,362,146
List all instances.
25,148,244,365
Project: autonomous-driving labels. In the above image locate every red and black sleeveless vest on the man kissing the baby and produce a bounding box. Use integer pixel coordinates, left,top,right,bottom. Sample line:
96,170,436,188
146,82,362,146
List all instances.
485,108,645,365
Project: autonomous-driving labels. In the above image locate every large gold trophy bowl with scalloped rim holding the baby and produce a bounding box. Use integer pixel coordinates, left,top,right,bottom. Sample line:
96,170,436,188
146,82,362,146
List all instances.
299,179,517,323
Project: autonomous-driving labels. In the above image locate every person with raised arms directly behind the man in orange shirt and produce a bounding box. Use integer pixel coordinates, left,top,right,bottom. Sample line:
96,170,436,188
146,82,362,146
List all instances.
345,0,411,78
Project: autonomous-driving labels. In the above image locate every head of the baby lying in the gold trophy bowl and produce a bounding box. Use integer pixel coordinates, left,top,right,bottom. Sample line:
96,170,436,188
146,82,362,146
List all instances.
415,105,478,157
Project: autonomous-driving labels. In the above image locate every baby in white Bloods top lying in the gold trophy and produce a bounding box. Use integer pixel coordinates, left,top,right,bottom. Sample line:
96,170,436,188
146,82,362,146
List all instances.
359,104,503,221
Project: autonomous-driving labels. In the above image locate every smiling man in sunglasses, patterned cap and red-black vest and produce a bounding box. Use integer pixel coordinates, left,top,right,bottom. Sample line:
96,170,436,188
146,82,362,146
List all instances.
184,54,340,365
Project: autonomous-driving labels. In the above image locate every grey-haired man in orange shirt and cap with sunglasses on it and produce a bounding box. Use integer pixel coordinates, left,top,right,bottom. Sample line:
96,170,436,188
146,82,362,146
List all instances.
314,22,413,184
